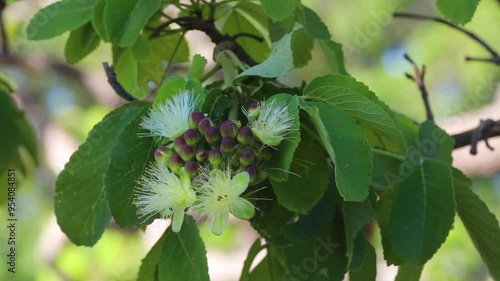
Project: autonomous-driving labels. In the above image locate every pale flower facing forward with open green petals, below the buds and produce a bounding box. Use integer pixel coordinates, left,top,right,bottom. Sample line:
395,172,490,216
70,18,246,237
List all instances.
193,167,255,235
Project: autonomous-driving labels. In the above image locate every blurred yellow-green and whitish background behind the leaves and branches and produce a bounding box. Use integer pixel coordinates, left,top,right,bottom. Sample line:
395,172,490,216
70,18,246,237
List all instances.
0,0,500,281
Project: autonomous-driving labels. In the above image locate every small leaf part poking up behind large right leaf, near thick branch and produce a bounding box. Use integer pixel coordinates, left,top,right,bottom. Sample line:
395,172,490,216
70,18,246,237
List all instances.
418,120,454,165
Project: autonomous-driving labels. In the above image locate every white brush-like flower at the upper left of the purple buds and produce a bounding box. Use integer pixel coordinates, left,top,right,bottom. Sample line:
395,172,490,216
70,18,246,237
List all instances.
141,90,199,140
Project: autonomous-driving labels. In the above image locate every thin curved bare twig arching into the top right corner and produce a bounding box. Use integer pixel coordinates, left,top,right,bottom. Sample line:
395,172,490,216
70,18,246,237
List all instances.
394,13,500,65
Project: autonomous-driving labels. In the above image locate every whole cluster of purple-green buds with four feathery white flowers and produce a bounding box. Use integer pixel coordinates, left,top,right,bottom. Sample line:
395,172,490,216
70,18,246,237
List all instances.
134,91,293,235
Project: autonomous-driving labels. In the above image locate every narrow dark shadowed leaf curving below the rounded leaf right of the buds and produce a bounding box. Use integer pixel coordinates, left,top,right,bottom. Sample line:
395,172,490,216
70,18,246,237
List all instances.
283,180,339,243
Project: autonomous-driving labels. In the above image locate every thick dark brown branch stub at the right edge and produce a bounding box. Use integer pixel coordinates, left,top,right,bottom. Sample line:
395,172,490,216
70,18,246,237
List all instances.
452,119,500,155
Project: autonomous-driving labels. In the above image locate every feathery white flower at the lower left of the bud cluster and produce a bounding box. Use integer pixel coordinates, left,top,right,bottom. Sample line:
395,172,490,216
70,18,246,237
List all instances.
134,161,196,232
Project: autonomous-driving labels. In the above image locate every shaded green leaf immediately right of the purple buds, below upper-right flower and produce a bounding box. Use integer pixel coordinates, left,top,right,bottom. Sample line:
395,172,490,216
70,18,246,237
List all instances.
270,133,329,214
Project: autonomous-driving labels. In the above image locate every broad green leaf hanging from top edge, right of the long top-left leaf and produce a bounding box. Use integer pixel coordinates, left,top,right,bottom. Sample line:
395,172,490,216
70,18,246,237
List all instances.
104,0,161,47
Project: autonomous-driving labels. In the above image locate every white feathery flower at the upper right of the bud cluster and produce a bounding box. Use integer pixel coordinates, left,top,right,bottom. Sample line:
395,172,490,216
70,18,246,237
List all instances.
244,101,294,146
